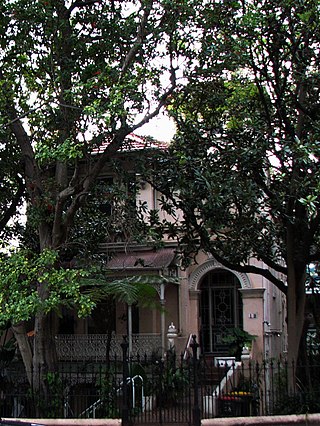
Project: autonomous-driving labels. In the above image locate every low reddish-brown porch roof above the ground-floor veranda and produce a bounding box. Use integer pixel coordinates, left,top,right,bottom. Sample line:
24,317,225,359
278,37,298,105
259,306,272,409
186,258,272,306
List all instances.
108,249,175,270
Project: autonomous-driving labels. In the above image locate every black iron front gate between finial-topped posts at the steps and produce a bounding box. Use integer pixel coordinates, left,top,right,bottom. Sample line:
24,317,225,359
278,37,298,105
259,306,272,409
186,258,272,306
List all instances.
121,337,200,426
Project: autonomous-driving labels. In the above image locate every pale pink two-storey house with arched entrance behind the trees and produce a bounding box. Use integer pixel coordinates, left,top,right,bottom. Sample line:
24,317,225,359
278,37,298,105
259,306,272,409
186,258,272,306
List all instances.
57,135,286,361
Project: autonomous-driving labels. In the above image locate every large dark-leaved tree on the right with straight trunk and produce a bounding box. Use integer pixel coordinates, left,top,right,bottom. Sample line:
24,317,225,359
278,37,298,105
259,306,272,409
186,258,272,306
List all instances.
144,0,320,366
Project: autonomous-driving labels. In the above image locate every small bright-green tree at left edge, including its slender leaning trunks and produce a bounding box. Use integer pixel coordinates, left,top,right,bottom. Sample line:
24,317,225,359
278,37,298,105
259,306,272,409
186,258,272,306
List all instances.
0,249,94,387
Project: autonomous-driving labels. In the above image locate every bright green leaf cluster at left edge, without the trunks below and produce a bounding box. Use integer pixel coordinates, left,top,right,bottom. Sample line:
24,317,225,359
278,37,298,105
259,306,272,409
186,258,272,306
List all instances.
0,250,94,325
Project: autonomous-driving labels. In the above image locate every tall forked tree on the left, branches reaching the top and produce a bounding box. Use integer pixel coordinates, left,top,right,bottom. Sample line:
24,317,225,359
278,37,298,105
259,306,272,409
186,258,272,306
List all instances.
0,0,202,392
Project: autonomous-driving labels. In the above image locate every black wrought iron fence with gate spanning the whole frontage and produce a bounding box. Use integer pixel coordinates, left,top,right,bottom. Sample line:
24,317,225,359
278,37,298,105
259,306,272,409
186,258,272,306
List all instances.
0,341,320,425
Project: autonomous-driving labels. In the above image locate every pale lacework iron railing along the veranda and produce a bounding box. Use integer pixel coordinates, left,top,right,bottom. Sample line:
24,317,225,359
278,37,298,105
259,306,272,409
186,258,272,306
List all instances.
56,334,161,361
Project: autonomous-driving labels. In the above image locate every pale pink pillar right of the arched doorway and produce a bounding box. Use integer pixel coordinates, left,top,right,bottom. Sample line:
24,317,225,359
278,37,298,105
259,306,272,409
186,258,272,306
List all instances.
239,288,266,359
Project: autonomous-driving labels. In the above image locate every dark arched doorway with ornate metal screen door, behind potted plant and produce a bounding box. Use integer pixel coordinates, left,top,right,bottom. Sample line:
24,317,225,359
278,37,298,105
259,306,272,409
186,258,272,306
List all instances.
199,269,243,355
